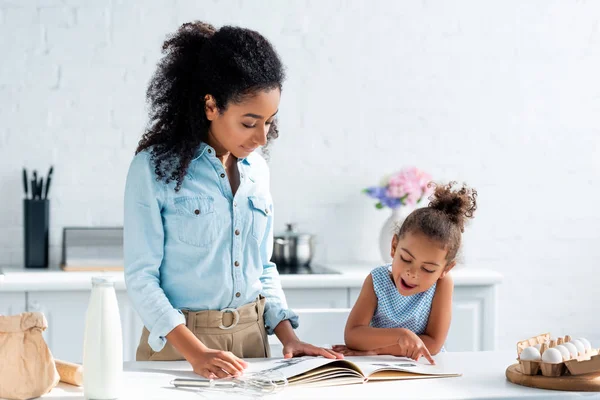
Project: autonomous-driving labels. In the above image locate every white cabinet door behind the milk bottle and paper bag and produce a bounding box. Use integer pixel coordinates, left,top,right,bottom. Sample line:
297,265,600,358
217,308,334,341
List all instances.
27,290,142,363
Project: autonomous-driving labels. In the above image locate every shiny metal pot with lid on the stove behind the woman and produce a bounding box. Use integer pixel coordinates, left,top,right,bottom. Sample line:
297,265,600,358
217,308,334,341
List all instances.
272,224,314,266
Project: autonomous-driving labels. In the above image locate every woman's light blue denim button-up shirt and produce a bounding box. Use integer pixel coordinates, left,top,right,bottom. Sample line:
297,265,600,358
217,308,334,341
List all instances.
124,144,298,351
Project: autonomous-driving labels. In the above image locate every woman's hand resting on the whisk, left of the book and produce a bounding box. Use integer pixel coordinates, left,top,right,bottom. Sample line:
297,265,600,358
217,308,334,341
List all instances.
190,349,248,379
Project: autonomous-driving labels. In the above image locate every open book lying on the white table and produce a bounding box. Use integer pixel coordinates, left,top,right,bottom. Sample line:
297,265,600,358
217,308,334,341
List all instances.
171,356,462,386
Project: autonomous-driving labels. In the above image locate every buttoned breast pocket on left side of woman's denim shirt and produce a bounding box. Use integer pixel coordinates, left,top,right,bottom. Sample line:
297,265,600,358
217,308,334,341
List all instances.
175,196,217,247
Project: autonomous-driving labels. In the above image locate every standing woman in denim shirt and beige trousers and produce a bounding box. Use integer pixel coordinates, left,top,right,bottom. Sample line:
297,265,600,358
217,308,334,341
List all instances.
124,22,342,378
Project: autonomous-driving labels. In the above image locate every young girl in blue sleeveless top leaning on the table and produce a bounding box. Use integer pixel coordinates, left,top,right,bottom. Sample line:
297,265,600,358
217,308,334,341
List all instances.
333,182,477,364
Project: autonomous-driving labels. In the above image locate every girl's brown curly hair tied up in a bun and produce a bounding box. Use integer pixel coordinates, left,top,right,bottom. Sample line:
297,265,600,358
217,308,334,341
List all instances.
396,182,477,262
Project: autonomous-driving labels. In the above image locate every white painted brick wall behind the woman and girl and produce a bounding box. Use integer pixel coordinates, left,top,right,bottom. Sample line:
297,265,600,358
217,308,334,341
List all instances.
0,0,600,348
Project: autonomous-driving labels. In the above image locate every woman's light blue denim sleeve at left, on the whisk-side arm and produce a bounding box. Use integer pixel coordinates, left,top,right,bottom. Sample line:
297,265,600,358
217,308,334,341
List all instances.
123,152,185,351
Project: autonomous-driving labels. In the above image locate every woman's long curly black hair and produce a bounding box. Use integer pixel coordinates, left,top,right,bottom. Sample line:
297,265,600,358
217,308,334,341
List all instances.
135,21,285,191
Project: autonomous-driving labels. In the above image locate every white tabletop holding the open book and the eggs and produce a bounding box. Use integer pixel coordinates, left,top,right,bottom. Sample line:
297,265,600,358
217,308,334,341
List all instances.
43,351,600,400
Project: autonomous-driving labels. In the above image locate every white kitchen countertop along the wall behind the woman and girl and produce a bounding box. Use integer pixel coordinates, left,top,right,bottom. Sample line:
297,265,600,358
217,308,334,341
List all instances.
0,263,502,292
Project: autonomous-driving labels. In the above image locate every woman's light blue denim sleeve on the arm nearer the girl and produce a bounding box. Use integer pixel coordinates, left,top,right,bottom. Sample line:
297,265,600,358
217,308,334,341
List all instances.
260,191,298,335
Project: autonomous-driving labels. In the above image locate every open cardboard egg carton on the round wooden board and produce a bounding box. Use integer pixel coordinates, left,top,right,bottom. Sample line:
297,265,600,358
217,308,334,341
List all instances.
517,333,600,376
